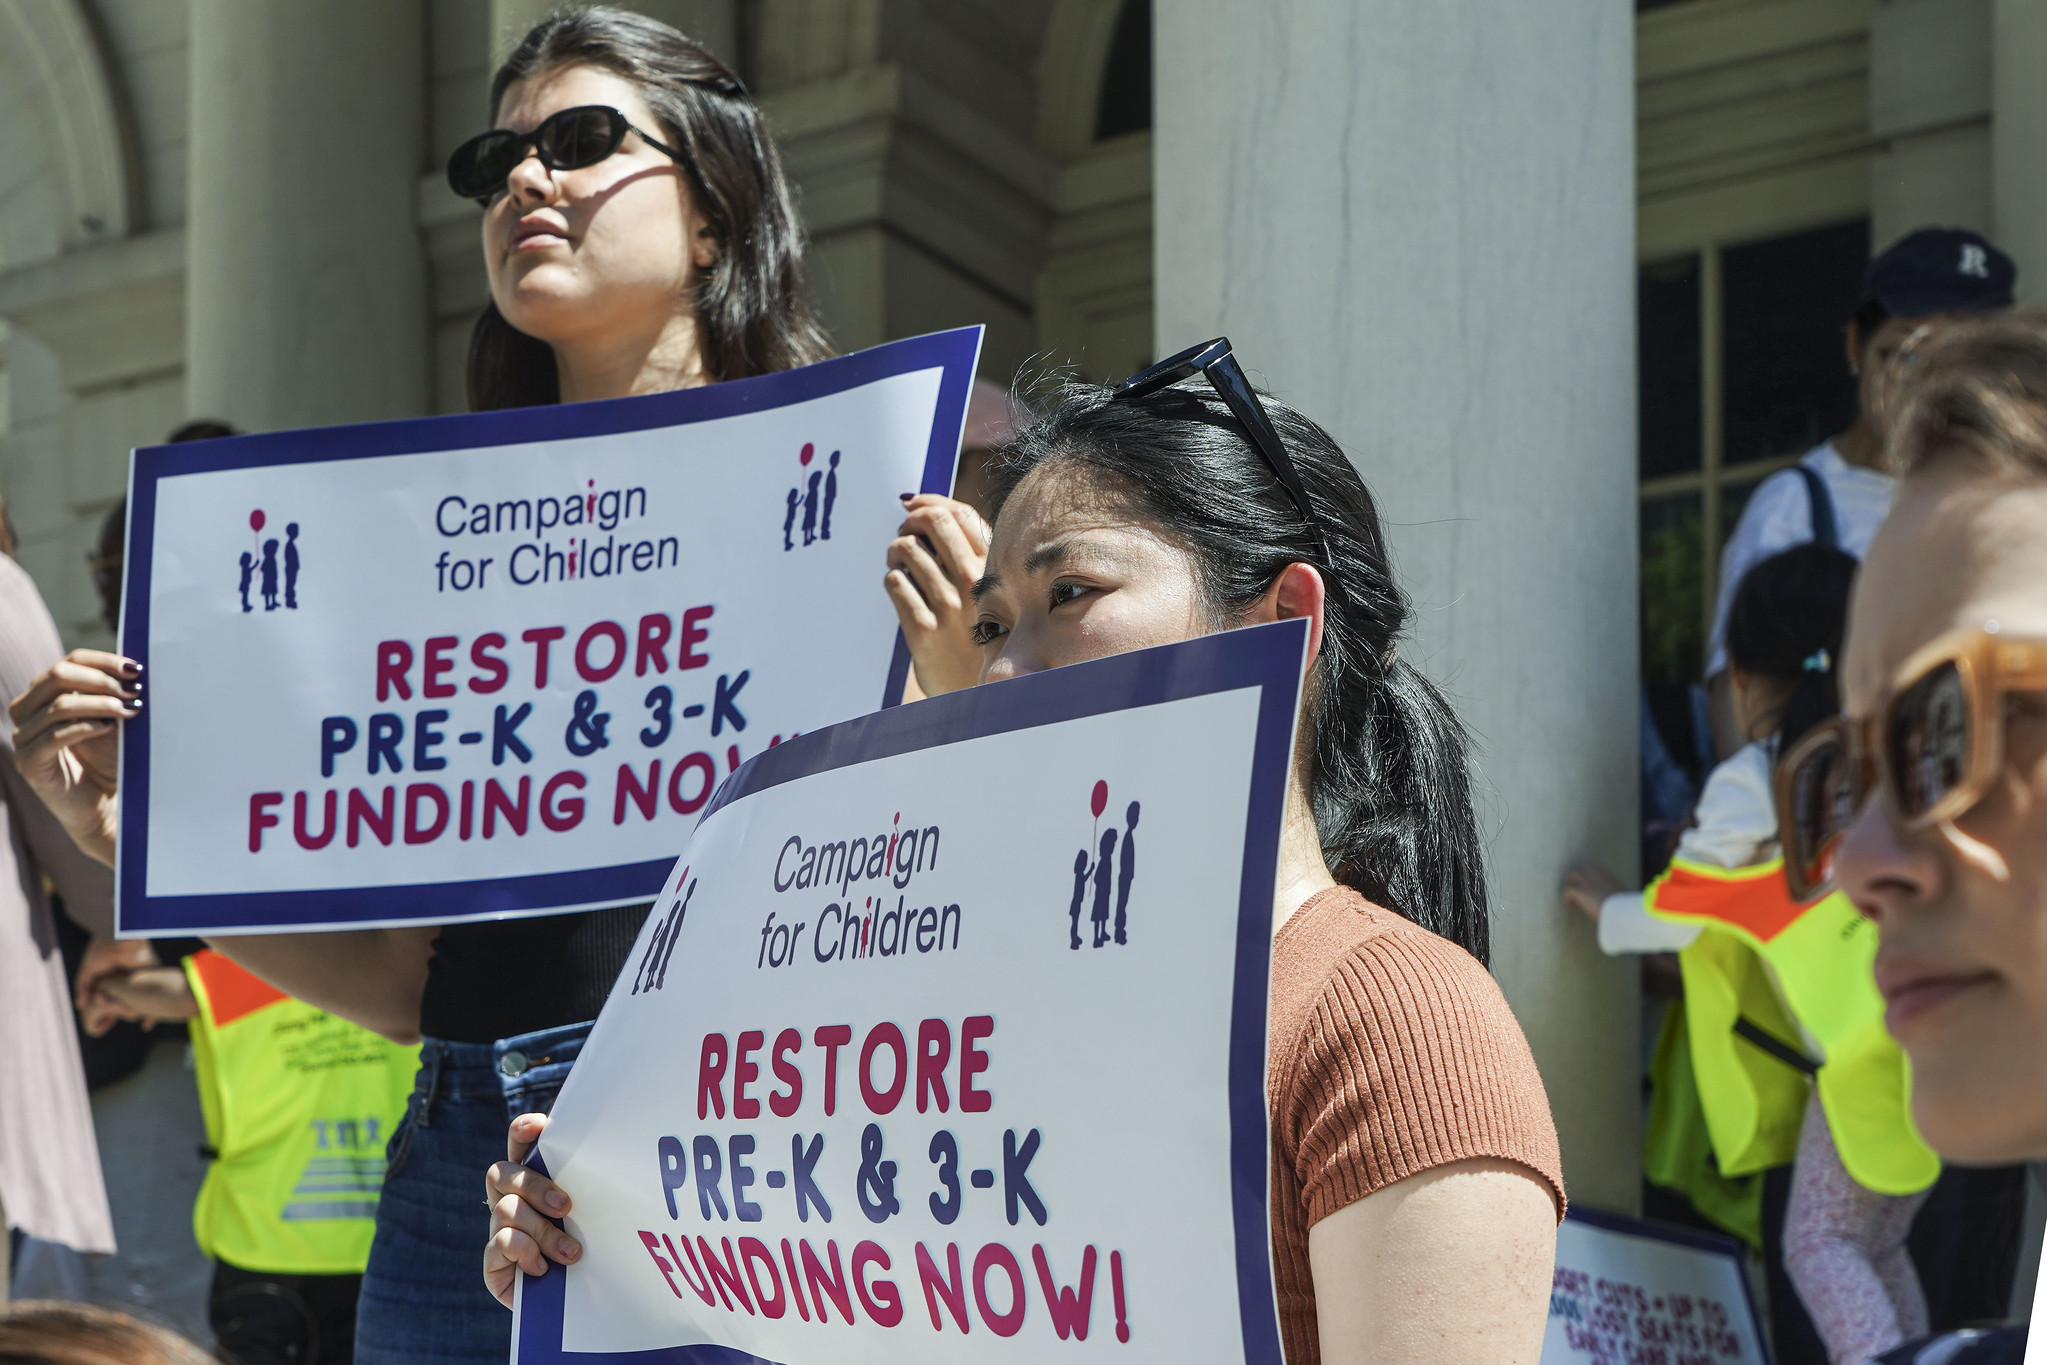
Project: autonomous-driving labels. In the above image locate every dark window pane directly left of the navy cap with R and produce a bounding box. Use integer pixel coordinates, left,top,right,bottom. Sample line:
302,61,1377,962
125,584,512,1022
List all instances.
1722,219,1869,465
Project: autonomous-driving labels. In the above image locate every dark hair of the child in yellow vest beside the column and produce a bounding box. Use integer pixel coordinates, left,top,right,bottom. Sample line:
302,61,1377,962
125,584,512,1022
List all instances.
1728,542,1855,753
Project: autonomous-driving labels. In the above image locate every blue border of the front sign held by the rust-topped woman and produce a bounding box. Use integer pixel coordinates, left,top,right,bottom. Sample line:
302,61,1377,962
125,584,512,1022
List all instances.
512,618,1308,1365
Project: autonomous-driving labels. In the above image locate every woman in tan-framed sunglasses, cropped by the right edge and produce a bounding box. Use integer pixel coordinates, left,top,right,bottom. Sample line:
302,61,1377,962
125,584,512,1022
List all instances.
1777,317,2047,1365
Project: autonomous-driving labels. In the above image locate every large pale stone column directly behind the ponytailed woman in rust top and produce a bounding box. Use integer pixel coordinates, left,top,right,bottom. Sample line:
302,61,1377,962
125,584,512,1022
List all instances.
1155,0,1642,1209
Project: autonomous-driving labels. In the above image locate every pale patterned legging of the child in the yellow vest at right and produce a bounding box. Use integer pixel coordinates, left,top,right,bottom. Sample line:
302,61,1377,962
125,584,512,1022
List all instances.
1785,1095,1926,1365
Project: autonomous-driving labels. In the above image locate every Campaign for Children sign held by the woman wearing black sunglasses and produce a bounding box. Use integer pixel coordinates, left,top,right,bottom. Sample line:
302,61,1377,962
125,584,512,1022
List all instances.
117,327,981,935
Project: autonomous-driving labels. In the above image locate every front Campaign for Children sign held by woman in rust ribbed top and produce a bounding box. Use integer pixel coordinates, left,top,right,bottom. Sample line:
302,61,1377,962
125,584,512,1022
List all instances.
516,620,1306,1365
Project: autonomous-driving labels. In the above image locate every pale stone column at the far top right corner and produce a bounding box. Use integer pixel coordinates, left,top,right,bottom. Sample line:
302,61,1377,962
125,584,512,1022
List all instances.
1990,0,2047,303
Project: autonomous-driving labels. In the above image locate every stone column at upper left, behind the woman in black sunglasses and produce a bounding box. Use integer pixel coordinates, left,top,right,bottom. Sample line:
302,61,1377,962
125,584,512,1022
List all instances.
186,0,428,430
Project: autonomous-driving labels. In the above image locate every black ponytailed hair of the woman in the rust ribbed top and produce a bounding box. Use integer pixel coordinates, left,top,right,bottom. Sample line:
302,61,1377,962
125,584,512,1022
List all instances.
993,383,1492,962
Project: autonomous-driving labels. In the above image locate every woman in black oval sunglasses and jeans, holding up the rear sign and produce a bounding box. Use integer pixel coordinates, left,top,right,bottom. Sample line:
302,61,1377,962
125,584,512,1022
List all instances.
14,8,829,1365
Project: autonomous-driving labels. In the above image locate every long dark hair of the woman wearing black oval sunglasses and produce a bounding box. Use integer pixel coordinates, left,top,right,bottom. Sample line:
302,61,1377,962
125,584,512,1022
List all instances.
469,6,831,411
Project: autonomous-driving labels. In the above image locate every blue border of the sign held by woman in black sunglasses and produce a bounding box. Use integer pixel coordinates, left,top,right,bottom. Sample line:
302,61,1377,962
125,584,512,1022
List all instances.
115,325,983,935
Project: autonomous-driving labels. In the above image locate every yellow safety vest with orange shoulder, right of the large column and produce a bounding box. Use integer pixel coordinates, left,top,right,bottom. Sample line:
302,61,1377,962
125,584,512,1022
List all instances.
1644,857,1941,1195
